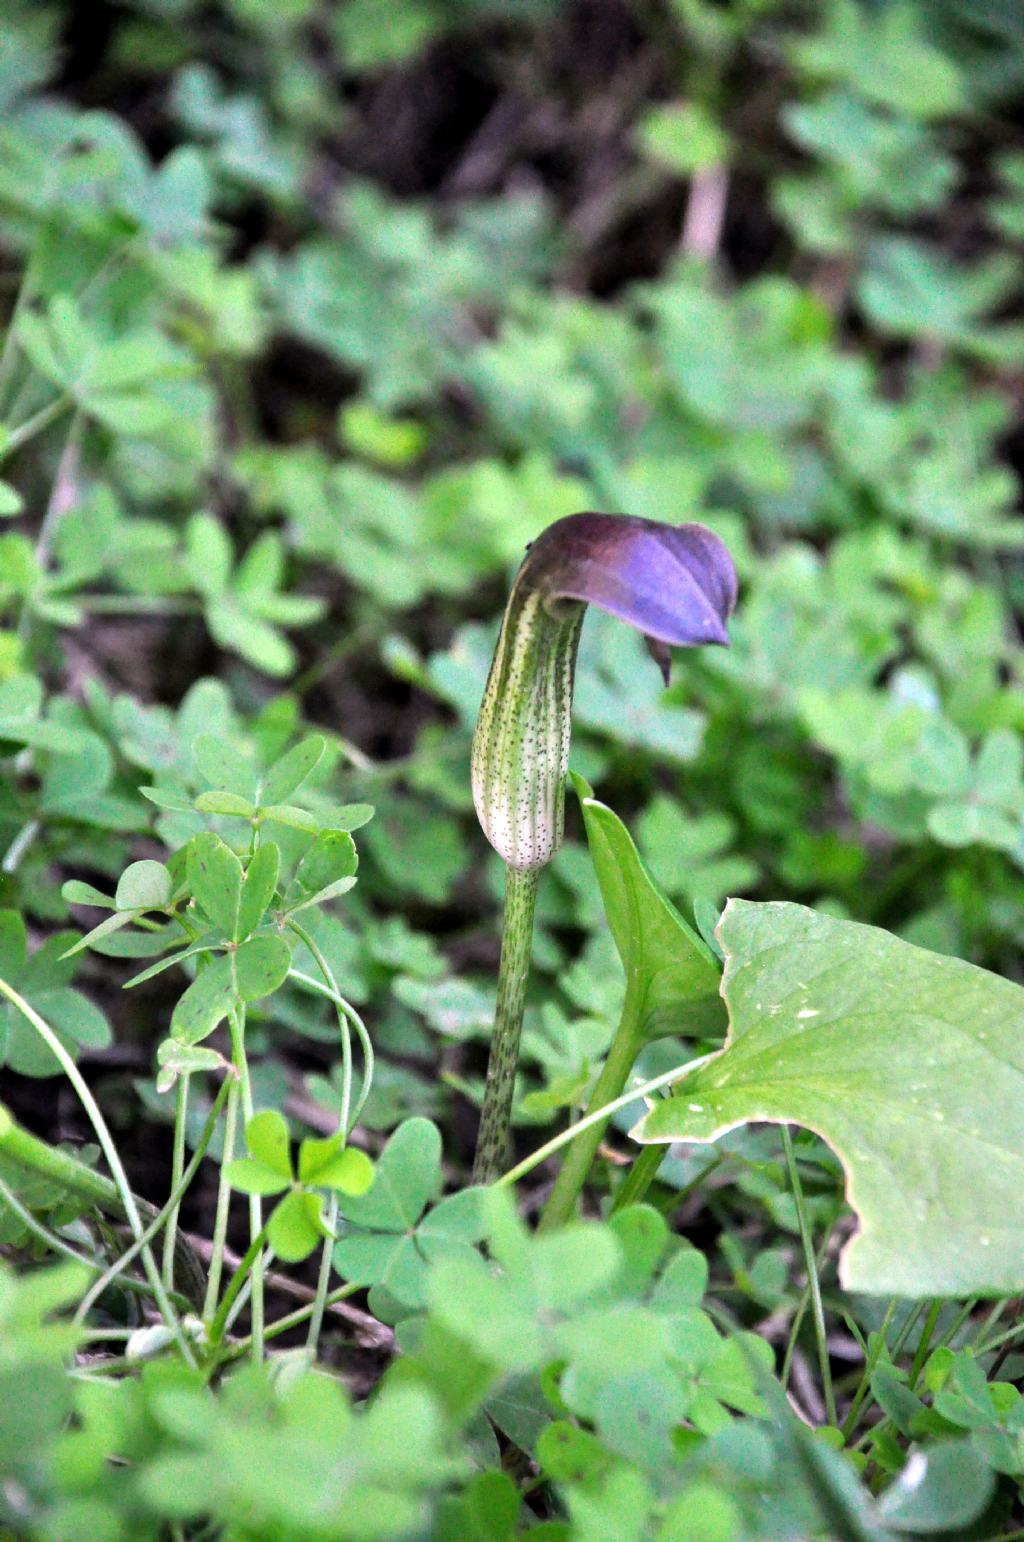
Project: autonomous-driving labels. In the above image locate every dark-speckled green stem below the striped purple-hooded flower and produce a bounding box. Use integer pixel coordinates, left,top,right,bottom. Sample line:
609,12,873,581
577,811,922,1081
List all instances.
473,864,537,1183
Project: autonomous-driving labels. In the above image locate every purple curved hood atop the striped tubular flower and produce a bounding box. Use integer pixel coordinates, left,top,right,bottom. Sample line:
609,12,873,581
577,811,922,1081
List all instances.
518,513,736,648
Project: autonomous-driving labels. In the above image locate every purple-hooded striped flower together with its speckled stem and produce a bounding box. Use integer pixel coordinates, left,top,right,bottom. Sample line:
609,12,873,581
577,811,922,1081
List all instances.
472,513,736,1183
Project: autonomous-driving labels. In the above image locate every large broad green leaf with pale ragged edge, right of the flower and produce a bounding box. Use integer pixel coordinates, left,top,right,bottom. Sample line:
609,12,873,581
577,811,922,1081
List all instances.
634,899,1024,1297
